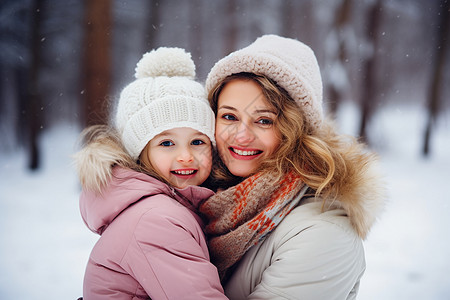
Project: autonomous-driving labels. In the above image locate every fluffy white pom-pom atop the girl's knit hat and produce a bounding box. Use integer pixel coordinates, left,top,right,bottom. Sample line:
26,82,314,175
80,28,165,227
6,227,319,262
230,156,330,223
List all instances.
134,47,195,79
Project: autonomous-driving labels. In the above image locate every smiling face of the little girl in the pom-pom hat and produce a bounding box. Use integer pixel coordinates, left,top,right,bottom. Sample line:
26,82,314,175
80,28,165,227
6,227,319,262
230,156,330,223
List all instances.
141,127,212,188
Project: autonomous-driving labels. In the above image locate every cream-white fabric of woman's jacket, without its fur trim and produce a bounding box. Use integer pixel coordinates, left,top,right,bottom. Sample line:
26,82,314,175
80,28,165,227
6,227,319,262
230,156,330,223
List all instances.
225,203,365,299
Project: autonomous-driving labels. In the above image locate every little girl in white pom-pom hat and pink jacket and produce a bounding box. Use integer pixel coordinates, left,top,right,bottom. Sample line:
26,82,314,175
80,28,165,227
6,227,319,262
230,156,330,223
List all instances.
76,48,226,300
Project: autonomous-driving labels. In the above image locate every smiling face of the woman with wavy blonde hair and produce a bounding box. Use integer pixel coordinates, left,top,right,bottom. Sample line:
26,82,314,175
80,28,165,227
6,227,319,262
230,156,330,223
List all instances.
216,79,280,177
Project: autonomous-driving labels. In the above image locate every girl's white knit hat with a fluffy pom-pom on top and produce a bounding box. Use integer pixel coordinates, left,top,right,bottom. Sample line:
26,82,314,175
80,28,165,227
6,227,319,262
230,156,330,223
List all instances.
115,47,215,159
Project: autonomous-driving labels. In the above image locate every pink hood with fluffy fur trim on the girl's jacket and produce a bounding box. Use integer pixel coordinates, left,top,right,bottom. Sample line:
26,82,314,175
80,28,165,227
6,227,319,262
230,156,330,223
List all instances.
75,132,214,234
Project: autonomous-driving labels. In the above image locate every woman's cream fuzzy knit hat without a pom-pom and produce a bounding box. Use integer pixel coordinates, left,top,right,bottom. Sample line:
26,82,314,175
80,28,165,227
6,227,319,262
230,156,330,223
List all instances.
206,35,323,129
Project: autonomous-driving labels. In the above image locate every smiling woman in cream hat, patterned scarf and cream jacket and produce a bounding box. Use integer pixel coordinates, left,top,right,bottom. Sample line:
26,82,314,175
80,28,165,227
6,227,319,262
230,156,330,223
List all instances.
201,35,383,299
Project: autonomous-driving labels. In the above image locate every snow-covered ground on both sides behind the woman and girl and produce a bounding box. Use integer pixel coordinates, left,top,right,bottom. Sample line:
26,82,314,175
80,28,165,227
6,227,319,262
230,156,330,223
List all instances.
0,105,450,300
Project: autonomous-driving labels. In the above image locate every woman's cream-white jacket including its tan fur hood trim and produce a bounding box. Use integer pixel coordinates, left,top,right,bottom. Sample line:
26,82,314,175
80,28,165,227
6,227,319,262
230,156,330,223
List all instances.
224,164,385,300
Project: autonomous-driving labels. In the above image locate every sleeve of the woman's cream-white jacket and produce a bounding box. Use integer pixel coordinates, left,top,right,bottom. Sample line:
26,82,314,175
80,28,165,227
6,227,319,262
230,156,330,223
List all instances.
247,221,365,300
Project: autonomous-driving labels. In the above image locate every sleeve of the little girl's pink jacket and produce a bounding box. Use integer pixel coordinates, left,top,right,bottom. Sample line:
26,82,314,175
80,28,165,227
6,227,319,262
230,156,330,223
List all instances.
124,210,227,299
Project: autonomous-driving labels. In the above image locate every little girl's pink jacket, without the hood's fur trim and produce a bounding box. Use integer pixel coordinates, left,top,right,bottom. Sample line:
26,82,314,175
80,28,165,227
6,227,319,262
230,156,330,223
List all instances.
80,167,226,300
